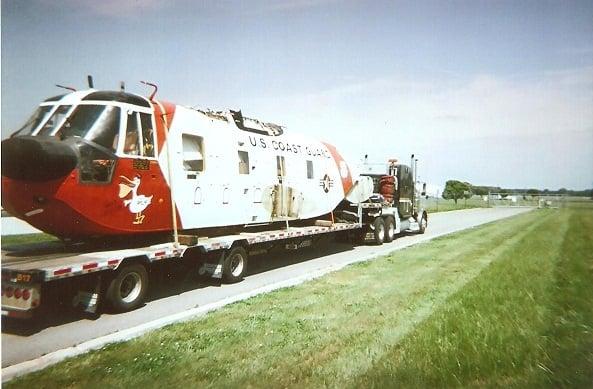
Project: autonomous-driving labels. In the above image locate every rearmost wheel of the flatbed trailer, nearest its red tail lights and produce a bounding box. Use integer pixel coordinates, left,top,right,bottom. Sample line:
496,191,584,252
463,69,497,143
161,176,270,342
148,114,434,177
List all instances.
106,264,148,312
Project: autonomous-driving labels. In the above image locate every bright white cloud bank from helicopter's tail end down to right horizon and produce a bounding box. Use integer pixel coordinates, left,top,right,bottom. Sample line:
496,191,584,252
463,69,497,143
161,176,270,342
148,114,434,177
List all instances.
244,67,593,188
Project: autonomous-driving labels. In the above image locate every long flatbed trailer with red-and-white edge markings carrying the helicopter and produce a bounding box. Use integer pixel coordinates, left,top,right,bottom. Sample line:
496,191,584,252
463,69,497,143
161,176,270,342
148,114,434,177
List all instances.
2,218,363,318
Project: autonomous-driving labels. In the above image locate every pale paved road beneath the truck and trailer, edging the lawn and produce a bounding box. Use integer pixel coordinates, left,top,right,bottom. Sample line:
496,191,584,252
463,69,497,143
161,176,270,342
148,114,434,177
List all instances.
2,208,531,368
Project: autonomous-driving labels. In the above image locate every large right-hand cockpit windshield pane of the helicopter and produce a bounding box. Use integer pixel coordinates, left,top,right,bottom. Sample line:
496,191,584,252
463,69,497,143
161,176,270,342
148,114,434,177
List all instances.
56,105,120,151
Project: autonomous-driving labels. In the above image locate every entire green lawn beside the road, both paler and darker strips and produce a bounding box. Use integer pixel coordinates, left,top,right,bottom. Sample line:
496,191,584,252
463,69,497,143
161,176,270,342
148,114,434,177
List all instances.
5,205,593,388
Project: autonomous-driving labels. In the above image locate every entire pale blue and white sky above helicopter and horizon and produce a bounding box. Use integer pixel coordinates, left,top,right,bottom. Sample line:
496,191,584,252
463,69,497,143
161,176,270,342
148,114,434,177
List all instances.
1,0,593,190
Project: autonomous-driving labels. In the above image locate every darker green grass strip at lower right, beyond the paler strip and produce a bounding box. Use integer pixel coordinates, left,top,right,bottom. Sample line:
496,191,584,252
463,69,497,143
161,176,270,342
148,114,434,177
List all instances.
355,203,593,388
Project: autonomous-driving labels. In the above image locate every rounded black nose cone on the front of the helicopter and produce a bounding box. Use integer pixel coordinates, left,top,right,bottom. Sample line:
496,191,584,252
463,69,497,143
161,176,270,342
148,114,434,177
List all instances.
1,136,78,181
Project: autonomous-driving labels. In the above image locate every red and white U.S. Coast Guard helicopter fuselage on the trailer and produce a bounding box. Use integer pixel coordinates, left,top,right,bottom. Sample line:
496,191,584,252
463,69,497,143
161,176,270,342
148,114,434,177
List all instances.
1,77,365,239
